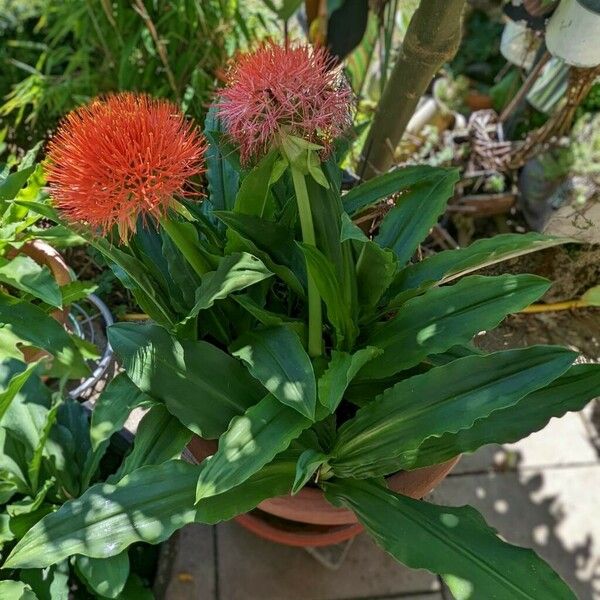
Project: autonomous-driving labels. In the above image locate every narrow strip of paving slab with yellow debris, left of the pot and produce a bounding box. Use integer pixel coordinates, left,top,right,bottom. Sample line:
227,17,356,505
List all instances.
154,524,216,600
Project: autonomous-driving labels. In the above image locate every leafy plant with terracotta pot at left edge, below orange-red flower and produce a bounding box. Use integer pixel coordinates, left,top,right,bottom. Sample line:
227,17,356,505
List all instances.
0,158,95,379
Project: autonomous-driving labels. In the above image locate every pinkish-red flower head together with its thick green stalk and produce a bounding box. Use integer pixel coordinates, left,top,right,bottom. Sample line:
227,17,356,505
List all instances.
219,42,352,356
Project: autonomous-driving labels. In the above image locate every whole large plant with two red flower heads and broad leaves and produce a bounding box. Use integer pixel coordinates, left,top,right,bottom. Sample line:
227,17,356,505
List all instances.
4,43,600,600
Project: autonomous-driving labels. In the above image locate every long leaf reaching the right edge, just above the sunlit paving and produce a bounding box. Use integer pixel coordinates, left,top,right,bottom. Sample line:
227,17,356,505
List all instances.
412,364,600,469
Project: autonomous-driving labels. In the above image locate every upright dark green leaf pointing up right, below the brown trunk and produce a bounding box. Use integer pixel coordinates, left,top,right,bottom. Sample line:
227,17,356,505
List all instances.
375,169,459,264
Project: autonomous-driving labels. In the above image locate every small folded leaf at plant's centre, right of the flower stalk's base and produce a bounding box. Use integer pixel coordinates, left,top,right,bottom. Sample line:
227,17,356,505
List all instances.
319,346,382,413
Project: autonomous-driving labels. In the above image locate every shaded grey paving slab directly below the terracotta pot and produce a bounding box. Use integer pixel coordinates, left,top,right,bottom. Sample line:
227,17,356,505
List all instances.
217,523,439,600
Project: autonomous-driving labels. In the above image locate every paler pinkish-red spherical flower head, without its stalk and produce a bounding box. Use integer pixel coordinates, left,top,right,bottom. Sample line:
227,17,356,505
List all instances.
219,42,352,163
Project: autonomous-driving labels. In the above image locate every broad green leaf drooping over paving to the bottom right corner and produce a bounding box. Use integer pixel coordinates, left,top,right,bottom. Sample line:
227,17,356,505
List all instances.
323,479,576,600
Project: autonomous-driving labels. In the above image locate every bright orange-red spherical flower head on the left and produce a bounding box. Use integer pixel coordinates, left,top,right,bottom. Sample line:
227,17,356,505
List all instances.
46,93,205,240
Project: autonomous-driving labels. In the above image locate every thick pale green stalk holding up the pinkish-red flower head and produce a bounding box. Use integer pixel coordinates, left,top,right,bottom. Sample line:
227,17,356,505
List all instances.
290,165,323,357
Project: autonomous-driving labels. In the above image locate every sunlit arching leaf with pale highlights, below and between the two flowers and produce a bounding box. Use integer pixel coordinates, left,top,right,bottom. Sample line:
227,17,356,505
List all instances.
184,252,273,322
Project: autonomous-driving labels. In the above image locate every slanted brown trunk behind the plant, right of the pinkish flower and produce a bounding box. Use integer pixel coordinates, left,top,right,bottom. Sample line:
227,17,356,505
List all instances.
359,0,465,179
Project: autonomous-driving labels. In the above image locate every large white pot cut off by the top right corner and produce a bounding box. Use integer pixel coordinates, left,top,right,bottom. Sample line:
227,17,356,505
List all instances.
546,0,600,67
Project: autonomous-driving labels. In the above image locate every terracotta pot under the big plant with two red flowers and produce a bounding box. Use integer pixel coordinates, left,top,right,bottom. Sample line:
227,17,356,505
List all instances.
188,437,460,546
